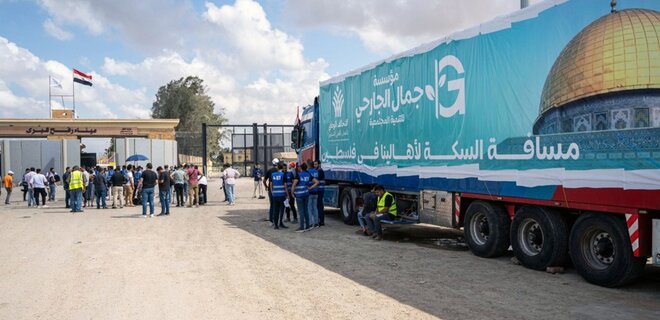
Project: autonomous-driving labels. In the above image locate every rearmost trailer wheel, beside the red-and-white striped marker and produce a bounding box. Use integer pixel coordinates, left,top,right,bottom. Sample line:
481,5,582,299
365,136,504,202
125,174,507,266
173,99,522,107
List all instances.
569,213,646,288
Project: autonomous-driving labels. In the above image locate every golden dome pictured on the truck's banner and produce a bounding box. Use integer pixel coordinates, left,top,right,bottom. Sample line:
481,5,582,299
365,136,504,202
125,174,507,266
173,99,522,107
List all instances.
540,9,660,114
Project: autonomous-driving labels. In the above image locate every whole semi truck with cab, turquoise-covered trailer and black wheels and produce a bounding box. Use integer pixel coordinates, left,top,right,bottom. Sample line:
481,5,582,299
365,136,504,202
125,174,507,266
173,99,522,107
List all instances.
292,0,660,287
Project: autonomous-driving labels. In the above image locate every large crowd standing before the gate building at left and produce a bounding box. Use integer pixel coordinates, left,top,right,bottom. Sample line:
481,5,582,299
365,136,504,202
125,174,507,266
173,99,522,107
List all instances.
0,163,208,216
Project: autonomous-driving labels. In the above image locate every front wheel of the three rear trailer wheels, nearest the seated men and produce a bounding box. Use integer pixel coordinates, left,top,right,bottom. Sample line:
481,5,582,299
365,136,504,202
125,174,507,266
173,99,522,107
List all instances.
464,201,510,258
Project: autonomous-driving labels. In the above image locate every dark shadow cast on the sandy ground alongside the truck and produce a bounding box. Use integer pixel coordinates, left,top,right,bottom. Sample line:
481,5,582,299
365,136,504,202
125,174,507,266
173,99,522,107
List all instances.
218,209,660,318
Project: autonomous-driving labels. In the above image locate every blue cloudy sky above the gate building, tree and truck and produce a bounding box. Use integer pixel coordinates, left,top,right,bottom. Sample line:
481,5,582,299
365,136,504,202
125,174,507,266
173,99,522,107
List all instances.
0,0,537,152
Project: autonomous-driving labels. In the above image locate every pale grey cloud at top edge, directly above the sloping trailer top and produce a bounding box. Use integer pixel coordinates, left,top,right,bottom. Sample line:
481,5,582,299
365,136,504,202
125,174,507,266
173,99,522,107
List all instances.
282,0,537,54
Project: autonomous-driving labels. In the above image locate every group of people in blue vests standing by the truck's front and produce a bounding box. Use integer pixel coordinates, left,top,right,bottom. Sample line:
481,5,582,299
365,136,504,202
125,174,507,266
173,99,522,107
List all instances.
262,159,325,232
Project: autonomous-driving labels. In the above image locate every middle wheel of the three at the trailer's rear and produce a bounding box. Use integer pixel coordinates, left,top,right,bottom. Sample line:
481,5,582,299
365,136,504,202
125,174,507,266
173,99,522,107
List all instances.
511,206,568,270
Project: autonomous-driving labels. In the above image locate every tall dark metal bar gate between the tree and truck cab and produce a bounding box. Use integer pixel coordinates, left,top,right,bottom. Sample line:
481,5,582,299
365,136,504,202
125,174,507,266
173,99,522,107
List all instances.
202,123,295,176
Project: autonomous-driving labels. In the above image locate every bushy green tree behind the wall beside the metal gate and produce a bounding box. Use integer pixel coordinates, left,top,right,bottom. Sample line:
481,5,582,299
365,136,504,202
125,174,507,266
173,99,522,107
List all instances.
151,76,227,159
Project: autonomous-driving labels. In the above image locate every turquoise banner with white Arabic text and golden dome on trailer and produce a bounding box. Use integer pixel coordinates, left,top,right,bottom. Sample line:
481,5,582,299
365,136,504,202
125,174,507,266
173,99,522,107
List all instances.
319,0,660,198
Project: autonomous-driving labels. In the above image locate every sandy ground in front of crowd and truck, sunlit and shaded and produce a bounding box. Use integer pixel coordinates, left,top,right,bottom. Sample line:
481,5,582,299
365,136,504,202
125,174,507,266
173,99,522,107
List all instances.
0,179,660,319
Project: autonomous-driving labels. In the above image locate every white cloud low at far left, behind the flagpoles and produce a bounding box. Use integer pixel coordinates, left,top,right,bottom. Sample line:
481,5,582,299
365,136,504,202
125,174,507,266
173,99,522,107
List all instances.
0,37,151,118
